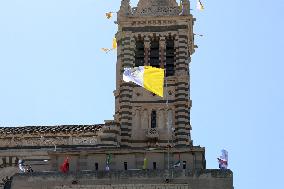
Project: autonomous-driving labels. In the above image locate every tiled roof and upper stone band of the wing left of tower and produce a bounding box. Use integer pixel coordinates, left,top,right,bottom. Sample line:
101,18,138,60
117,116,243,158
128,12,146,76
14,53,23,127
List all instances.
0,123,119,148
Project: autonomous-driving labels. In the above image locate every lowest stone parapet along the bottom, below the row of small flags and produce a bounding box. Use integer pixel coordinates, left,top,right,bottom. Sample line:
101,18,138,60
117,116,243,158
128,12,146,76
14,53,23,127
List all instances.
12,170,233,189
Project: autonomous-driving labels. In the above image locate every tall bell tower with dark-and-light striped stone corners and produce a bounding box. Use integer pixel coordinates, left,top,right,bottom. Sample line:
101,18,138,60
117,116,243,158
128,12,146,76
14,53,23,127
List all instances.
114,0,195,147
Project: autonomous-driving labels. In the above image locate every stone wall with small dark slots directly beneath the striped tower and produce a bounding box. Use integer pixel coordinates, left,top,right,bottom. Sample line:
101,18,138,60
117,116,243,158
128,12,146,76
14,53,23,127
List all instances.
49,147,206,171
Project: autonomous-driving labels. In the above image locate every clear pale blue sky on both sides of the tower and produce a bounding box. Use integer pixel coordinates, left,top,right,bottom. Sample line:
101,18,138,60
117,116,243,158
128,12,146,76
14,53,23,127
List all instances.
0,0,284,189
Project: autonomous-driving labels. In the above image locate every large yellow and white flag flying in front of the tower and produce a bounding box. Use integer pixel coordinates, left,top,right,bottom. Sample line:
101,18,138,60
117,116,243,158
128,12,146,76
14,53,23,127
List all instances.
123,66,165,97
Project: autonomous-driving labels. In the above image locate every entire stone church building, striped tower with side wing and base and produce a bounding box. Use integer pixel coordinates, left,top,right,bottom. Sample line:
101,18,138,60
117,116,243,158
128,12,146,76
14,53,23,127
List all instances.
0,0,233,189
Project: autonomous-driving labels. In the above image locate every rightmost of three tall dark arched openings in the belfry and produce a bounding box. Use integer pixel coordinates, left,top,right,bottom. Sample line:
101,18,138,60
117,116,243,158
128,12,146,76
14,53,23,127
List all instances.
165,36,175,76
